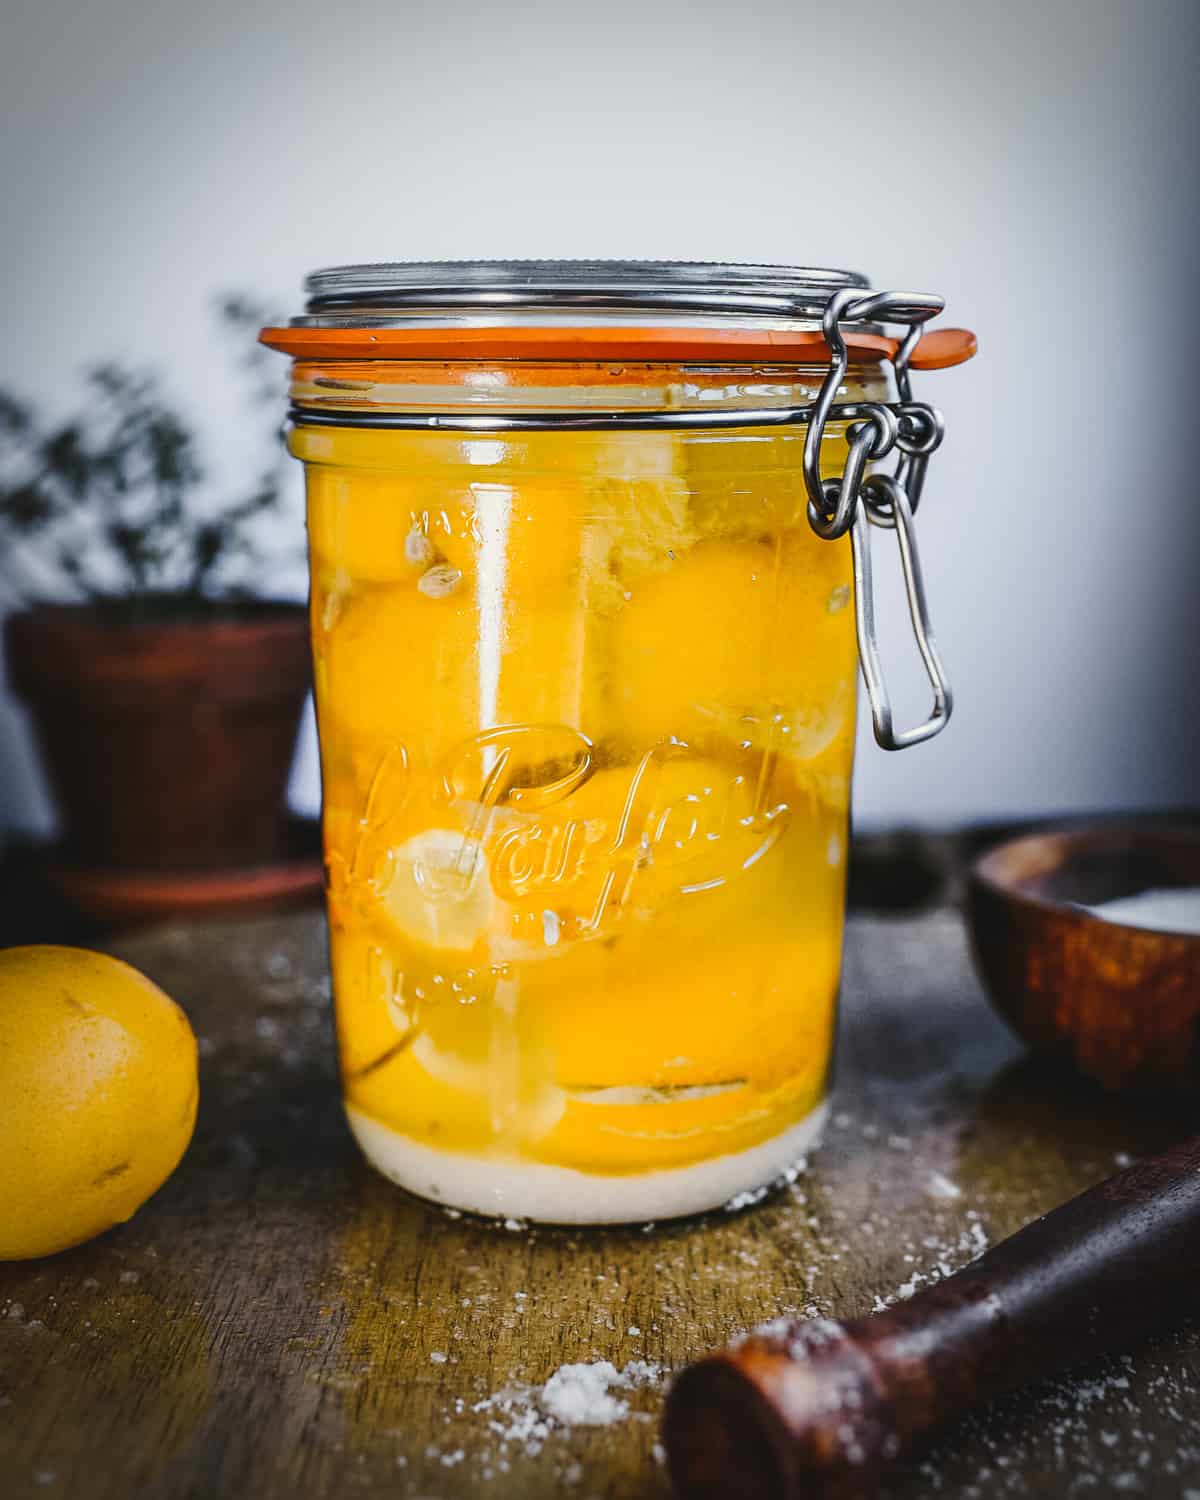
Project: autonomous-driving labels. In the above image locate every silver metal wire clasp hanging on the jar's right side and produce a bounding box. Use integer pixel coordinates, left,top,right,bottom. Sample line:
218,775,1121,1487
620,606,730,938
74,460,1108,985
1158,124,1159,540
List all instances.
804,288,954,750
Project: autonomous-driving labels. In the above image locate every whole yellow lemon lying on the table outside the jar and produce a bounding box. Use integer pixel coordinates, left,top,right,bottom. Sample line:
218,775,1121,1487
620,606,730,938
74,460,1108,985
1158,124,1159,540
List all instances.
0,947,200,1260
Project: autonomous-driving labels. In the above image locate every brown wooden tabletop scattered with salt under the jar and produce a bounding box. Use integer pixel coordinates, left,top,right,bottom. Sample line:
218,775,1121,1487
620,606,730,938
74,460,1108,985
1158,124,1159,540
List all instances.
0,882,1200,1500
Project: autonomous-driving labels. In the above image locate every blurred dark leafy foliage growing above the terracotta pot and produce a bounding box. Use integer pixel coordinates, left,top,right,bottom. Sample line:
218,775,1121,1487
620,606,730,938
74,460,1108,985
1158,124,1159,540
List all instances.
0,294,299,614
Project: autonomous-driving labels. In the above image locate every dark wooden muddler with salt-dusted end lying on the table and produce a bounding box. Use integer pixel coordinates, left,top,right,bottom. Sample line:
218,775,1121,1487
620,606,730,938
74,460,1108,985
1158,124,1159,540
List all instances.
663,1139,1200,1500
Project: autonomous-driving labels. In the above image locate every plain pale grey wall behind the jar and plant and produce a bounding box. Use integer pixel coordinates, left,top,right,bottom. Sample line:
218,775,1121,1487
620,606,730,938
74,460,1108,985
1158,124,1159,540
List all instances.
0,0,1200,828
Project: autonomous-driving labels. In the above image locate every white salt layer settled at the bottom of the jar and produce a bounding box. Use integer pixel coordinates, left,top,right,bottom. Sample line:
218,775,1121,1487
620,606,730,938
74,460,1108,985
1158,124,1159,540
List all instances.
337,1101,828,1224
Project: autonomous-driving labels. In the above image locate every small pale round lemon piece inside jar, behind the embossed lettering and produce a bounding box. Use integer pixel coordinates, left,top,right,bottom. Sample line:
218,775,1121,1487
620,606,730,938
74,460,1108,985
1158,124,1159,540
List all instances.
381,828,492,953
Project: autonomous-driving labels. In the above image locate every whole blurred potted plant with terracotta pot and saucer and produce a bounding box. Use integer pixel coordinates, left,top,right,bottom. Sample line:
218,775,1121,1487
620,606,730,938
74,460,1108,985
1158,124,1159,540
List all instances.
0,297,320,920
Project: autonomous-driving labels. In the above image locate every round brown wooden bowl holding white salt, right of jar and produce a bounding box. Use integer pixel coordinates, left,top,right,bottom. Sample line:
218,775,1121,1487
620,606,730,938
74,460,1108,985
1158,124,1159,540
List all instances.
968,825,1200,1091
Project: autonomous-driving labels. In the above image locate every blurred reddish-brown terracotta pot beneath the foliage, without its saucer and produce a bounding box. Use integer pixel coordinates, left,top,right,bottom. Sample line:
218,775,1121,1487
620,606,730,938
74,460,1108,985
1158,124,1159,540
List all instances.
6,605,312,870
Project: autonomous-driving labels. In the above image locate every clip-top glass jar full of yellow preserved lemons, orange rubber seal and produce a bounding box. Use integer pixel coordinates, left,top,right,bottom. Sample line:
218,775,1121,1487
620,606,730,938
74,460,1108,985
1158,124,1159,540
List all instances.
264,263,972,1223
